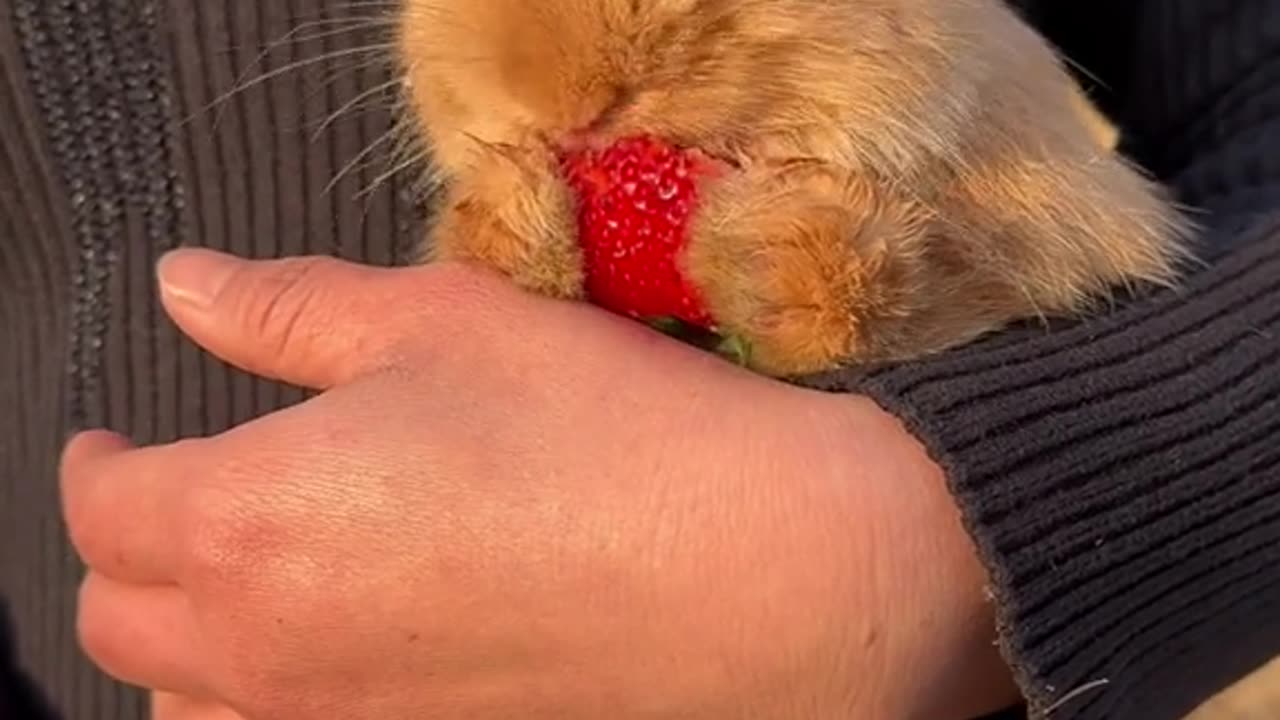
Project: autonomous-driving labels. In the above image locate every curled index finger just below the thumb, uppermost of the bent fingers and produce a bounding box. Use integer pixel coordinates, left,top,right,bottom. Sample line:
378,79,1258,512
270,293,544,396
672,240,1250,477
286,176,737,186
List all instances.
59,430,209,584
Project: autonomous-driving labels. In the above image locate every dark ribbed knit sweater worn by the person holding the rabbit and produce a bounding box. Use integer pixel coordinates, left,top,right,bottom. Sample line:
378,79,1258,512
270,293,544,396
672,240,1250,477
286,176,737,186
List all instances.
0,0,1280,720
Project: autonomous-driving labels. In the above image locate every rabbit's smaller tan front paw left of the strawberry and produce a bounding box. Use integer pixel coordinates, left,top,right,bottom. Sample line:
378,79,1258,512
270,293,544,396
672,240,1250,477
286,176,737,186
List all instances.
426,147,582,300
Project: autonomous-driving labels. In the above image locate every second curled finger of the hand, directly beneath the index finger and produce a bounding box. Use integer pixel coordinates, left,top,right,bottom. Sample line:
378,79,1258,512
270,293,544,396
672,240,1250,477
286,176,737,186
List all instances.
76,573,210,697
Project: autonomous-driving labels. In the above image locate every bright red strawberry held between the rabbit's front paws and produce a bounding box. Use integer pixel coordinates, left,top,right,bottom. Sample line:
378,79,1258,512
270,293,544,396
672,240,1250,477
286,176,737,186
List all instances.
563,137,716,329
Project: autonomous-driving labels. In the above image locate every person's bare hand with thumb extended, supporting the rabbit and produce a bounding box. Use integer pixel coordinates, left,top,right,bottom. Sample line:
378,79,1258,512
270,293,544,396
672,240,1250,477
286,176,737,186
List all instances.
61,252,1010,720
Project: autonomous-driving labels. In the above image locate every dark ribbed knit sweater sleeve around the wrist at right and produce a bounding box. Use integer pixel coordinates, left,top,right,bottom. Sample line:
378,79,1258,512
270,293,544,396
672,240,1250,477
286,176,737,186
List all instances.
808,0,1280,720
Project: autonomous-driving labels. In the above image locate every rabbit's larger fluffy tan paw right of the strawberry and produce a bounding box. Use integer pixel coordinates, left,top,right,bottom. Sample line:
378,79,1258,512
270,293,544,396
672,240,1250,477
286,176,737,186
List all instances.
684,164,929,375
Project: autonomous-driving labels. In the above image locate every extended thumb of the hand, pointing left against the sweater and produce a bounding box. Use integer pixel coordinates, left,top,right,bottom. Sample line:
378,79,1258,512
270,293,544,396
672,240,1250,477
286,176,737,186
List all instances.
157,249,394,389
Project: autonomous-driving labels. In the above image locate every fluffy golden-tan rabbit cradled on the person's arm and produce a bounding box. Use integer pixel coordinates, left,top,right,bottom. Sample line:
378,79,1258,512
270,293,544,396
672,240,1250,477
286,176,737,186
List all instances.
396,0,1190,377
